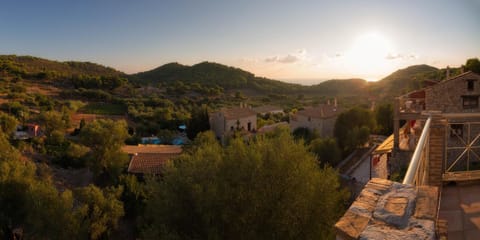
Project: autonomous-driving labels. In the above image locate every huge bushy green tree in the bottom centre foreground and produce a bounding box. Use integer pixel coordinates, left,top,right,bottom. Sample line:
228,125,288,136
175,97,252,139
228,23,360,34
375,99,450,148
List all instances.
143,131,346,239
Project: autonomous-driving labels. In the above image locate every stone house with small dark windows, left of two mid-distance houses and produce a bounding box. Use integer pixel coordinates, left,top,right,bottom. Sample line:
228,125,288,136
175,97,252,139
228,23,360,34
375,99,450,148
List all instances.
209,105,257,138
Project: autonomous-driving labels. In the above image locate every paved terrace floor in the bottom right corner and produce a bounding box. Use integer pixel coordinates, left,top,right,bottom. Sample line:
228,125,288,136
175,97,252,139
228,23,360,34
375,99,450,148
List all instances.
439,182,480,240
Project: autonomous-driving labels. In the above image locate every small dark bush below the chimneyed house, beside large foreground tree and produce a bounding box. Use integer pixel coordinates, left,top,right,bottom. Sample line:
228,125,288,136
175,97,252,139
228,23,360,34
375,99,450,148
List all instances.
309,138,342,166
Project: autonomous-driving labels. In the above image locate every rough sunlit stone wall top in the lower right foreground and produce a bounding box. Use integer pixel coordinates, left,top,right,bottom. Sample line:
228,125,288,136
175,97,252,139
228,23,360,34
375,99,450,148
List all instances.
335,178,438,240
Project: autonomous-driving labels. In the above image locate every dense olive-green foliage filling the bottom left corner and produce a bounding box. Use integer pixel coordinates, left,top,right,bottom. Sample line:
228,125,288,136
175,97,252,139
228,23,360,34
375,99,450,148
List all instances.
0,132,123,239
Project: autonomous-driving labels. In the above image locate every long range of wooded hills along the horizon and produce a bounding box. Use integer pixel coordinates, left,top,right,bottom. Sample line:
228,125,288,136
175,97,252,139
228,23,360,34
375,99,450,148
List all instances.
0,55,459,97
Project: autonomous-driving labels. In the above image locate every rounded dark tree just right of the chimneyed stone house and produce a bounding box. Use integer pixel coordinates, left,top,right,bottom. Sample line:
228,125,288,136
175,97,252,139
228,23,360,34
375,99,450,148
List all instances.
333,107,375,153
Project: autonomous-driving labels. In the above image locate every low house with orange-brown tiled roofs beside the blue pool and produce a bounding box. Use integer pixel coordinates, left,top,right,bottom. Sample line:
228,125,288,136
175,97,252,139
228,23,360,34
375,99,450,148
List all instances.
122,144,182,175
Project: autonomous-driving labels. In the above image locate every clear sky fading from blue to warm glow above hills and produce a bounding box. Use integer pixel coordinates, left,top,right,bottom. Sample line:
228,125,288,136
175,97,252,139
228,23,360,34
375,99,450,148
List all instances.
0,0,480,85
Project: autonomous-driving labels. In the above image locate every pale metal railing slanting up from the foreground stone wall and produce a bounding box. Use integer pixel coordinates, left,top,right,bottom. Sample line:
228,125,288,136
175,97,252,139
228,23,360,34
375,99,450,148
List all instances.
403,116,432,185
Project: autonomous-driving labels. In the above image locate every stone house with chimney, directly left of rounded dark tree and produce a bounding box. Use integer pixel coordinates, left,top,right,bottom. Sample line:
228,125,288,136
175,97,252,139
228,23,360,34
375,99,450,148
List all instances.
290,101,339,137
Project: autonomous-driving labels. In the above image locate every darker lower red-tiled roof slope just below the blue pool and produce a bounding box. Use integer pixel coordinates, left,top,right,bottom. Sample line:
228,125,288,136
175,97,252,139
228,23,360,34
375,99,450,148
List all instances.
128,153,179,174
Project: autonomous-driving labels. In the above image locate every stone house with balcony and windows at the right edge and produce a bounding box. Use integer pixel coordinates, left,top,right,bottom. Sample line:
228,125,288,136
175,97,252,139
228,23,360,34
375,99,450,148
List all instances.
394,72,480,181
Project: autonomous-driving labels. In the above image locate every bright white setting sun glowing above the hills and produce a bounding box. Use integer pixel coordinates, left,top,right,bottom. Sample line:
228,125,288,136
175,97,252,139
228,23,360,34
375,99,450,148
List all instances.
347,32,394,80
